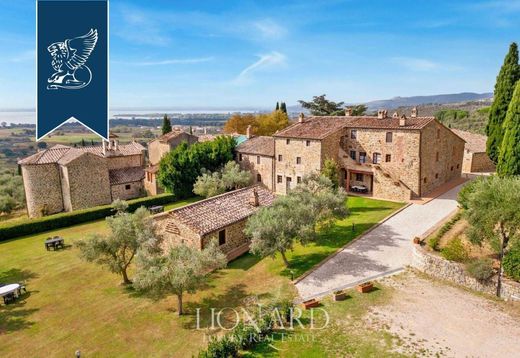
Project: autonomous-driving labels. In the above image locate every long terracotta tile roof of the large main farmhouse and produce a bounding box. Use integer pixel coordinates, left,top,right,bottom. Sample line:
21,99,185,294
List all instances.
274,116,435,139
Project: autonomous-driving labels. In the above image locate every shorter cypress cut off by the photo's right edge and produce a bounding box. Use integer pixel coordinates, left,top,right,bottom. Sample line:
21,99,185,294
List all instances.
497,81,520,176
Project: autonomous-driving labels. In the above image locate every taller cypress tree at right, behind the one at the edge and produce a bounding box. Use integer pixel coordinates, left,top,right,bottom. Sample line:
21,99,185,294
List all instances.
486,42,520,163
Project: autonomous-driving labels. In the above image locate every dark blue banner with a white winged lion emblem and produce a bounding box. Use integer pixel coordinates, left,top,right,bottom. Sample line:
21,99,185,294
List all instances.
36,0,109,140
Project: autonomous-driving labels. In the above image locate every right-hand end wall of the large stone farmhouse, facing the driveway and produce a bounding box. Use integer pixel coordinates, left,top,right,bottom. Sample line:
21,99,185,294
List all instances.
420,121,465,195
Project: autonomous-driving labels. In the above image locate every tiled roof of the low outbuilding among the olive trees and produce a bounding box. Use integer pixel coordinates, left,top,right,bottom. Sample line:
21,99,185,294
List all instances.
162,185,275,235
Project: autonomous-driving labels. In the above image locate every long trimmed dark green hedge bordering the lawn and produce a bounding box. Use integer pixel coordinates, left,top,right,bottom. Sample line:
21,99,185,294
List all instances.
0,194,175,241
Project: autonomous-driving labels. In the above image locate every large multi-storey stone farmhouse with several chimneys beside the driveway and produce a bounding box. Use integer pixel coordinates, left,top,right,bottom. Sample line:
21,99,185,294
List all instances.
237,109,465,201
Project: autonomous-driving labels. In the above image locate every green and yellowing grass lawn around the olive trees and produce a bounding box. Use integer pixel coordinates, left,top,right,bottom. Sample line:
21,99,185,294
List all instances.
0,197,400,357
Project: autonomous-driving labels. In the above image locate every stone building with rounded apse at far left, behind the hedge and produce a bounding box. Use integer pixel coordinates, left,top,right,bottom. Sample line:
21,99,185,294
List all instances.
18,135,144,217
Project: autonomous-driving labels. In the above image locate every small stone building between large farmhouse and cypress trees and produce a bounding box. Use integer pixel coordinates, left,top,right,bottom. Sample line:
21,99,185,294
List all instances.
452,129,496,173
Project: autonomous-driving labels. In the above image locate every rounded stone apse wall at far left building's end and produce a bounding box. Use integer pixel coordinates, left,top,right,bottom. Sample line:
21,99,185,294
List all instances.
22,163,64,217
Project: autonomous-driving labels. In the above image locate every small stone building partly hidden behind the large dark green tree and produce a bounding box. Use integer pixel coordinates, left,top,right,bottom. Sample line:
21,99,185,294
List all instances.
144,129,198,195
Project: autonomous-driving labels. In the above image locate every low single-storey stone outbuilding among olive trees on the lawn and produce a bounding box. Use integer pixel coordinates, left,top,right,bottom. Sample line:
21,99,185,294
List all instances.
154,185,275,260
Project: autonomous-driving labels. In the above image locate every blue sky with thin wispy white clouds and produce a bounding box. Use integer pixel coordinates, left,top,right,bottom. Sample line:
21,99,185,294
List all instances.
0,0,520,109
